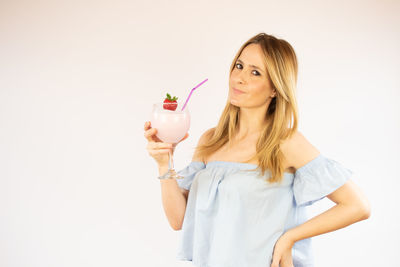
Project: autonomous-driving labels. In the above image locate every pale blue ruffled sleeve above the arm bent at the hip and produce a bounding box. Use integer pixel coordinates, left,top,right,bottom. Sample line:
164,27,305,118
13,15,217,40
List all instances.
293,154,353,206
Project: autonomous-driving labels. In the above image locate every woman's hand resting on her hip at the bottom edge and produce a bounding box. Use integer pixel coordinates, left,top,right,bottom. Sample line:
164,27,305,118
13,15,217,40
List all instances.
271,232,294,267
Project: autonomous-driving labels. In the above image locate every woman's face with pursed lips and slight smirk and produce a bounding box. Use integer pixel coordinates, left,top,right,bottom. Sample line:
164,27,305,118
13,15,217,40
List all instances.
229,44,276,108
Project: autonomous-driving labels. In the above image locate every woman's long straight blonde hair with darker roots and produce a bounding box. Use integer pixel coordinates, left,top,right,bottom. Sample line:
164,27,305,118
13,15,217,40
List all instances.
196,33,298,183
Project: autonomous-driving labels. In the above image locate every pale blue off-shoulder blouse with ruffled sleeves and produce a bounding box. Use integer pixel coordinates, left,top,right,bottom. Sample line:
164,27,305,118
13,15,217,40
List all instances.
177,154,353,267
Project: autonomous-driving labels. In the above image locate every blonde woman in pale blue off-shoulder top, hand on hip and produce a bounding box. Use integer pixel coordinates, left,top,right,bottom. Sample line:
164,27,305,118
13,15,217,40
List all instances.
144,33,370,267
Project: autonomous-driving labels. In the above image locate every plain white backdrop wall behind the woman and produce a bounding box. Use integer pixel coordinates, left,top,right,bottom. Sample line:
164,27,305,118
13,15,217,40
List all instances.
0,0,400,267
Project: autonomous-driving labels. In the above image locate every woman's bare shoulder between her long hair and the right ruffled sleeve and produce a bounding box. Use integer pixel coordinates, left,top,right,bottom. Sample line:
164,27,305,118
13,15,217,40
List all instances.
281,131,320,170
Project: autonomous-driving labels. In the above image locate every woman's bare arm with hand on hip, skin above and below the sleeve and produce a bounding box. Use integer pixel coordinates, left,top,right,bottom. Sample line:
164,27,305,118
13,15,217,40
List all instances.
271,132,371,267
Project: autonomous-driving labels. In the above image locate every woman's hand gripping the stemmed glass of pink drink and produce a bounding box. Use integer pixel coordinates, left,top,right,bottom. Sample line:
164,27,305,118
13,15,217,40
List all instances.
144,121,189,166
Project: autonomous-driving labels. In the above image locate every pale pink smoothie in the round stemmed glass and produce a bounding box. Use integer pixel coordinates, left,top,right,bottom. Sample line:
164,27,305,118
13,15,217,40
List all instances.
150,102,190,144
